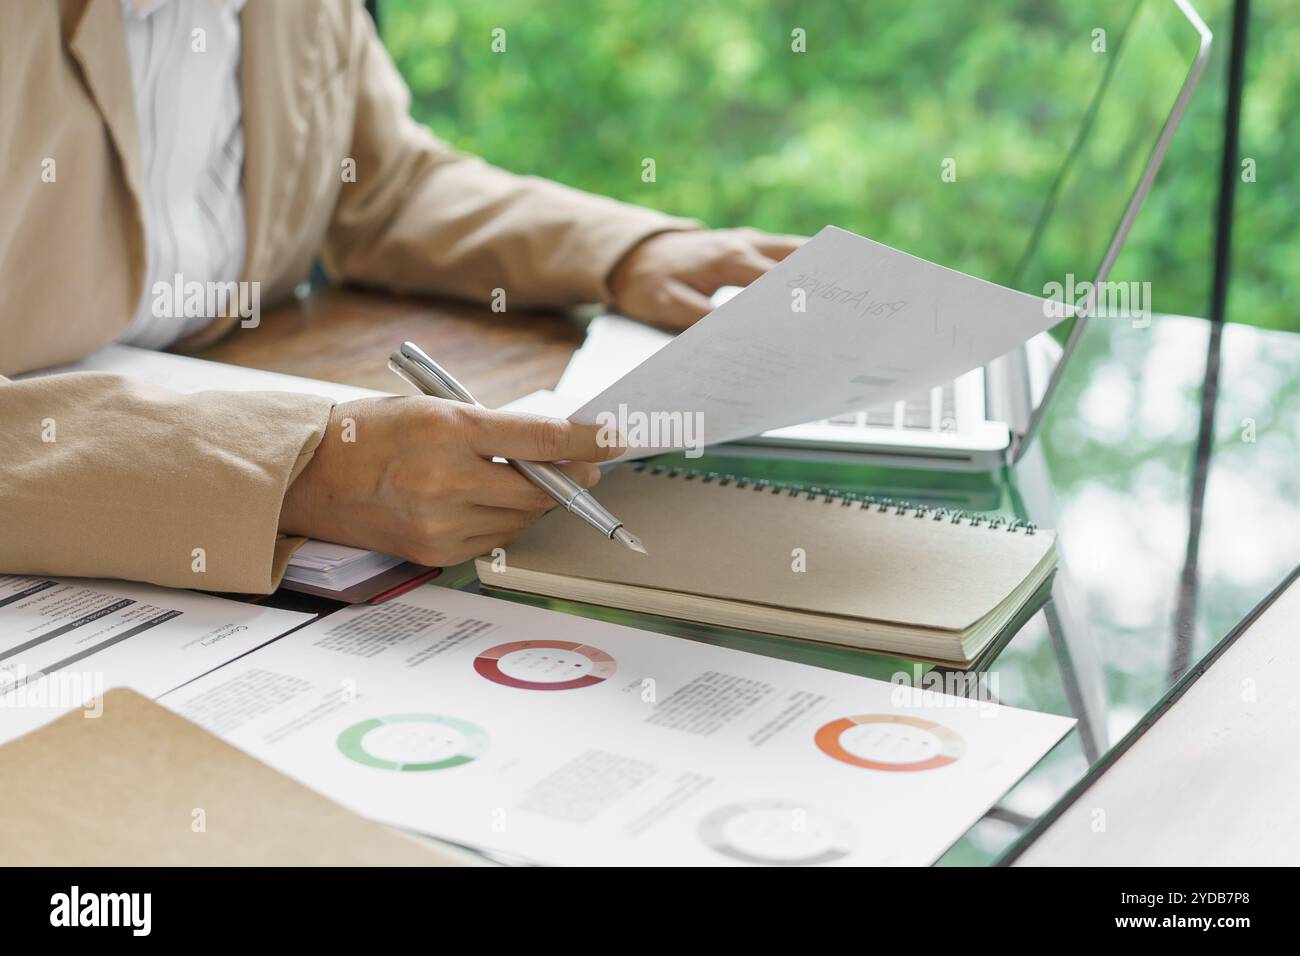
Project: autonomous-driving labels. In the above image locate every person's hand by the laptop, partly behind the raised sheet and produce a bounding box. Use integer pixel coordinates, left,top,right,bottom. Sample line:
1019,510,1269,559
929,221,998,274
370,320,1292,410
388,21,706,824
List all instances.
610,229,803,330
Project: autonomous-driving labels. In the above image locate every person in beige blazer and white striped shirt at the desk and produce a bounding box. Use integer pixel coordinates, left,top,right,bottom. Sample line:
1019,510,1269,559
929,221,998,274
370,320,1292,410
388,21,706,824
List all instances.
0,0,797,592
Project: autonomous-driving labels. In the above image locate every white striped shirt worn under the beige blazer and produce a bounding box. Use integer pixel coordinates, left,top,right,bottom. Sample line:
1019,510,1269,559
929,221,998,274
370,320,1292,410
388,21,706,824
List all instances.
118,0,244,349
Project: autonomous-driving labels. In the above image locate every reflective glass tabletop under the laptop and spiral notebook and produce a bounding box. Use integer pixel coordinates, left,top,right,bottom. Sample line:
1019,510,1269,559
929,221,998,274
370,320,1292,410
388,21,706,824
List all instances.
439,316,1300,865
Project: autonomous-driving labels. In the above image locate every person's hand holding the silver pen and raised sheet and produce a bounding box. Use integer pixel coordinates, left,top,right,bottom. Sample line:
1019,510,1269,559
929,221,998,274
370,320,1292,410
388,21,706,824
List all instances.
280,397,621,566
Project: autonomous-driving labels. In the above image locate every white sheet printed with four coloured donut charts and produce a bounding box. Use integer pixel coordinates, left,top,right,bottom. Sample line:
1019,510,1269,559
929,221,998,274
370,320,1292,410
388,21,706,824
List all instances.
161,585,1074,865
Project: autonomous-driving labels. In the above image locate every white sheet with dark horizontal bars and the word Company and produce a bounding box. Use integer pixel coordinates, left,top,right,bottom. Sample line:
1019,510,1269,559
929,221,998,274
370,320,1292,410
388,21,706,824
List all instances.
0,575,313,741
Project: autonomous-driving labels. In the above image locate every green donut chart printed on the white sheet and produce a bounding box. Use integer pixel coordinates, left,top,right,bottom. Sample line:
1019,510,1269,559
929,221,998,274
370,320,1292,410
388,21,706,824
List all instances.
335,714,489,773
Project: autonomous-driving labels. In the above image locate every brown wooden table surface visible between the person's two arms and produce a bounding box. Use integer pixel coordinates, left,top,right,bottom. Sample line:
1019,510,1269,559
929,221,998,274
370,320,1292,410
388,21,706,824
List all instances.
198,287,585,408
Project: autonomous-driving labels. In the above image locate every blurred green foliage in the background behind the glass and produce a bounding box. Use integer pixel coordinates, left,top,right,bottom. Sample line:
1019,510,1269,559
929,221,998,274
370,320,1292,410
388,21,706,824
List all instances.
380,0,1300,330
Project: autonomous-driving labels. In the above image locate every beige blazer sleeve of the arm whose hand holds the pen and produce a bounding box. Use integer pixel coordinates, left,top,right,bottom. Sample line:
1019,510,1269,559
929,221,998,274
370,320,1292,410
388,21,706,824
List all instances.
0,372,333,593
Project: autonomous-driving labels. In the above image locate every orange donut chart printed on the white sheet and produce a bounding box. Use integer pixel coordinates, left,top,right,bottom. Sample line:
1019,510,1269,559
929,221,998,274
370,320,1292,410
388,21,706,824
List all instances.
813,714,966,773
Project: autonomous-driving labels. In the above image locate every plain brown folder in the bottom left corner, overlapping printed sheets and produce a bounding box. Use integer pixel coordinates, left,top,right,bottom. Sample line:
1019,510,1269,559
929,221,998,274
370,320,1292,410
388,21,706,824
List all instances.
0,688,473,866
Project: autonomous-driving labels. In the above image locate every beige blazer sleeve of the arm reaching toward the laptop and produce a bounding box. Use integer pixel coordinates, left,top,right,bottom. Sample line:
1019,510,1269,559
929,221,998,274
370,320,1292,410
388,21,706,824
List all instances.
322,4,699,307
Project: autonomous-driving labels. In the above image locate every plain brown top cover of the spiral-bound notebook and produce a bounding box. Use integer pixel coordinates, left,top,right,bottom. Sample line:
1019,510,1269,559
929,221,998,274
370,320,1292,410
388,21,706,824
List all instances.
486,466,1054,631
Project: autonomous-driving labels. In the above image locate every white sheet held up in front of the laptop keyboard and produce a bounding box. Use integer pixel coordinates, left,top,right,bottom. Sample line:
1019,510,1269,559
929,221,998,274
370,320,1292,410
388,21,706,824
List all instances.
571,226,1069,457
